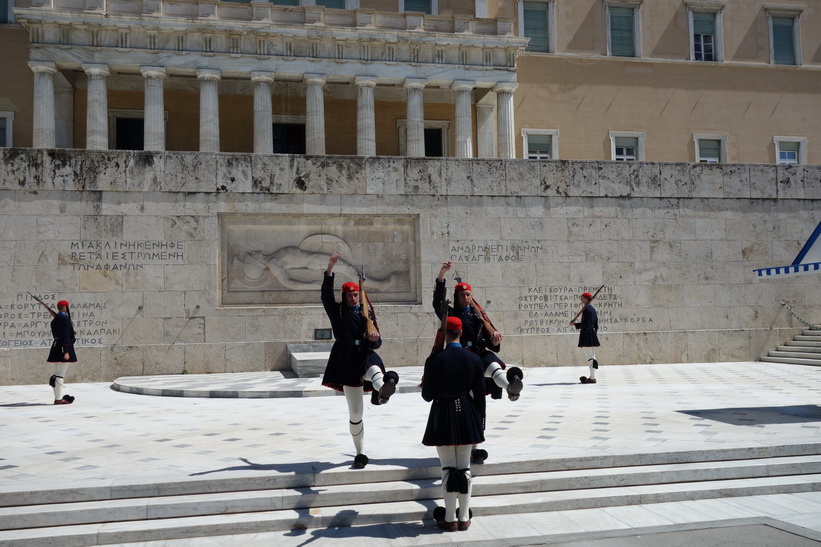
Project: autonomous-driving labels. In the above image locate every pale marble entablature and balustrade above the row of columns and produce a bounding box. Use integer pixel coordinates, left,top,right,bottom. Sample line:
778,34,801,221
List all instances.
15,0,528,85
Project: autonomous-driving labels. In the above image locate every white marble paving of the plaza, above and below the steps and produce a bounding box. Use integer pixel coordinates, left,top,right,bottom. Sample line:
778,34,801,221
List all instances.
0,362,821,545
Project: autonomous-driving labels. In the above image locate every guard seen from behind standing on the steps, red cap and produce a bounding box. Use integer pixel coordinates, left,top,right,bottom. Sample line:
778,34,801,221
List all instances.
422,317,485,532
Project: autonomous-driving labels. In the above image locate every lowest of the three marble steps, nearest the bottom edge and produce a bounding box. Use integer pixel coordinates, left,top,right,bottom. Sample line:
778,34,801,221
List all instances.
0,474,821,547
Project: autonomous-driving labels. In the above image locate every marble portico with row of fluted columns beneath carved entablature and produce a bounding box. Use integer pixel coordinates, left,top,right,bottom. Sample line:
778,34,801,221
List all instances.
15,0,527,158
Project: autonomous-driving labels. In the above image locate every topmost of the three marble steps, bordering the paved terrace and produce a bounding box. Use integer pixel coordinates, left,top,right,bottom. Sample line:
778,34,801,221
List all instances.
6,443,821,508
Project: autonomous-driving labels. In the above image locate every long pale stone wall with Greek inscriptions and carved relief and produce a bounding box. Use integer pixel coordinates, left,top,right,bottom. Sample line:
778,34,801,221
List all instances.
0,149,821,384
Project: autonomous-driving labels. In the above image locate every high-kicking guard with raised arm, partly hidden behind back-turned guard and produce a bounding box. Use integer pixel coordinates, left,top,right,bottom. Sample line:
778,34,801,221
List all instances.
433,260,524,463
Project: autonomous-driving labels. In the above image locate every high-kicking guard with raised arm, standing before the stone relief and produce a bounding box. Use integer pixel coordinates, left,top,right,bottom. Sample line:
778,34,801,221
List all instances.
322,253,399,469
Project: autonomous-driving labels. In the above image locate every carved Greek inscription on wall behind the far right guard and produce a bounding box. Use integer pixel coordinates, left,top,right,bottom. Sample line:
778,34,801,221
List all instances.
518,286,653,334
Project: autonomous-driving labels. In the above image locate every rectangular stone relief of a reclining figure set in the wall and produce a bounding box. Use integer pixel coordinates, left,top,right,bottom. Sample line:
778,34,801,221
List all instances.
220,214,419,305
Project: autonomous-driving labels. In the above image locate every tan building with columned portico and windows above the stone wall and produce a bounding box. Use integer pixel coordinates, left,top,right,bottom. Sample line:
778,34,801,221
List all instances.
0,0,821,164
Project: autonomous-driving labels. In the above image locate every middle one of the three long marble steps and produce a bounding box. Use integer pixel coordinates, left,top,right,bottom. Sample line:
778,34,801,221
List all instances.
0,455,821,530
